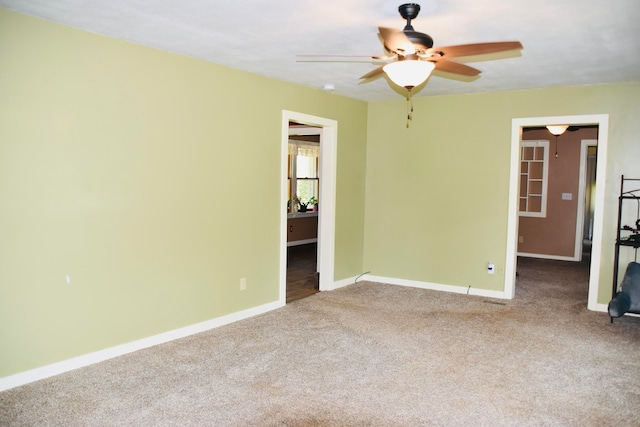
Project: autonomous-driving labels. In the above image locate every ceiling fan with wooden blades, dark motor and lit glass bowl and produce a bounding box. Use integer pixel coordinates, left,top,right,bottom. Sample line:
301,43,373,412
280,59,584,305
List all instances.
301,3,522,120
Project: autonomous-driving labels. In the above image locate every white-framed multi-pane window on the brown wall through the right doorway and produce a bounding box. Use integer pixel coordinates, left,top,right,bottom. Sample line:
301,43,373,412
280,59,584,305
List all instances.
519,141,549,218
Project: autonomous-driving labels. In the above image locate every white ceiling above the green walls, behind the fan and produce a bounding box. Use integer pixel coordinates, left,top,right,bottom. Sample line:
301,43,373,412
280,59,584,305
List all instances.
0,0,640,101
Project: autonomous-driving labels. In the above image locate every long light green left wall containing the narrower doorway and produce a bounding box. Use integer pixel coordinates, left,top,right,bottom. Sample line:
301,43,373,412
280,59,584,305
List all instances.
0,9,367,377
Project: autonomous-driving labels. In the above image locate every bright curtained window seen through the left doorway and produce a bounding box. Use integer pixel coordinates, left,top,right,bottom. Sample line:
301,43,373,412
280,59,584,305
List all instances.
288,141,320,212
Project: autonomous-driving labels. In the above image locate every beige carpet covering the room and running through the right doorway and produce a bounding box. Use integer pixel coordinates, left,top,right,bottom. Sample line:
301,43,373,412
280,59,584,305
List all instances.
0,259,640,426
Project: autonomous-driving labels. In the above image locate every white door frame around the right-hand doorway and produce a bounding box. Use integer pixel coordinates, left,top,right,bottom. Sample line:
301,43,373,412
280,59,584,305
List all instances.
504,114,609,310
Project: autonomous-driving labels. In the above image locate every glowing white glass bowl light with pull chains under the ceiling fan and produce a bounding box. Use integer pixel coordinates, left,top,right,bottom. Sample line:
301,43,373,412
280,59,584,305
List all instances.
382,54,436,127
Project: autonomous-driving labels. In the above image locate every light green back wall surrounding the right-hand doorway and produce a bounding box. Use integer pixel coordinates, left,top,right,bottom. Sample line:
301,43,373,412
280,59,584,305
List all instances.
364,80,640,304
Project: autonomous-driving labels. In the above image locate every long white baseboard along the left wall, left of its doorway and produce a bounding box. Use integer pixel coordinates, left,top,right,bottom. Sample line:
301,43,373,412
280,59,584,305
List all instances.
0,302,283,391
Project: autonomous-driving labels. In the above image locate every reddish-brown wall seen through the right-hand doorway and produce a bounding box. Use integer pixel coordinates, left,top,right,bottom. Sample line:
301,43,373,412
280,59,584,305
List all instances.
518,129,598,257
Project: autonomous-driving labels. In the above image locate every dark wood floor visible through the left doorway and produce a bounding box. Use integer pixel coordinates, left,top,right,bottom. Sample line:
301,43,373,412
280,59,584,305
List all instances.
287,243,318,303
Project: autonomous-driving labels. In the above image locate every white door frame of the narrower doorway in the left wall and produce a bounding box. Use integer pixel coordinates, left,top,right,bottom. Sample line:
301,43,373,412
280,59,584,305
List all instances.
279,110,338,305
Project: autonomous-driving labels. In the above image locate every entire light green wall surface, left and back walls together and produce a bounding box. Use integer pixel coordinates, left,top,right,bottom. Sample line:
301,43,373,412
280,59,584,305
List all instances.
0,9,640,377
